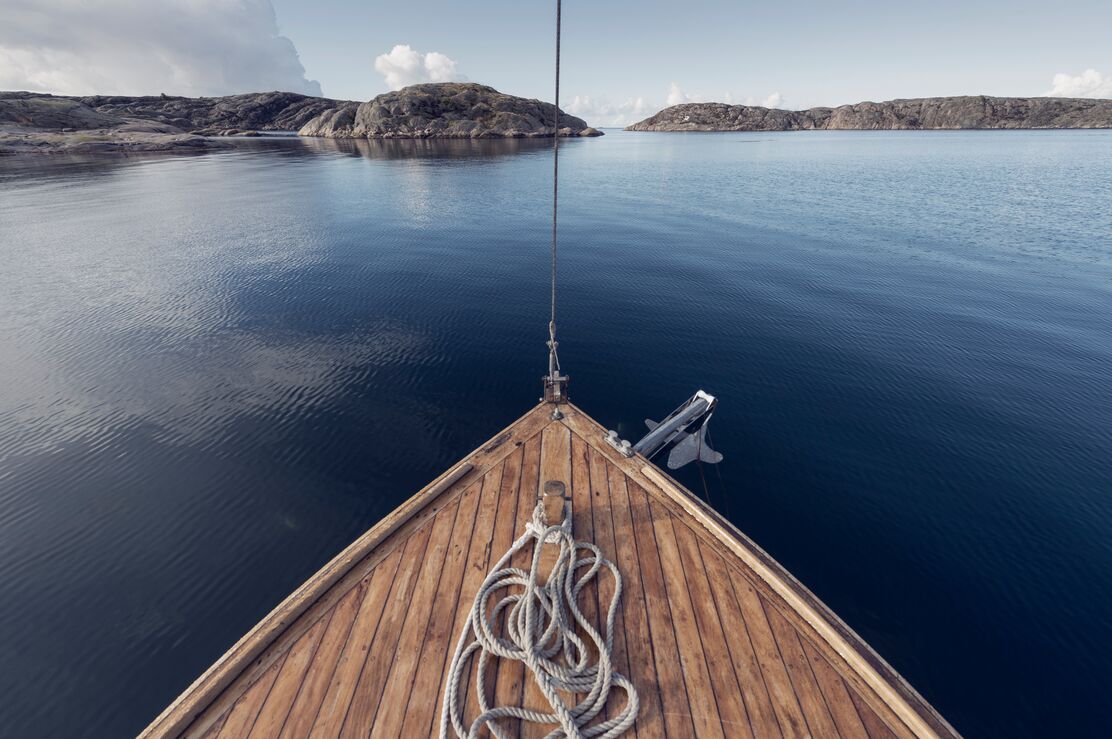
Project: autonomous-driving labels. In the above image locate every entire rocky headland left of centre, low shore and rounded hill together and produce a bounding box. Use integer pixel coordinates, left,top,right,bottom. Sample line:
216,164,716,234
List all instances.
0,82,602,153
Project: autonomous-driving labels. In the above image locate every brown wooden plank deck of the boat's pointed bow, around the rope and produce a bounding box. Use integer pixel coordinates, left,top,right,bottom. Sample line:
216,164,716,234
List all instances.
143,405,956,738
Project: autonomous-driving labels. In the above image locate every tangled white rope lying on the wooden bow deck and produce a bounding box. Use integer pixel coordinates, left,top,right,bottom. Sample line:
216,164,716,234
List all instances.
440,502,639,739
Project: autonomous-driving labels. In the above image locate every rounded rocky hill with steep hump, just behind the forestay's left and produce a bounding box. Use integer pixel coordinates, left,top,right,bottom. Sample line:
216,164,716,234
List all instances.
298,82,602,139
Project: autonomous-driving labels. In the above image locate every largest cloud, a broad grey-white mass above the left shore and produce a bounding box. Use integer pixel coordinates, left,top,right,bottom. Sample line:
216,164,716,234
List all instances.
0,0,321,96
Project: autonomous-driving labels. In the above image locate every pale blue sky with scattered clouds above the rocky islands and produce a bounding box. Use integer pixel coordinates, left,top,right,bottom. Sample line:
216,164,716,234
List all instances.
0,0,1112,126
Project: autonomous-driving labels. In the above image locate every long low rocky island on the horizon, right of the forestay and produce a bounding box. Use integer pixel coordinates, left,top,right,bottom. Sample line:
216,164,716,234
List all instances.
626,96,1112,131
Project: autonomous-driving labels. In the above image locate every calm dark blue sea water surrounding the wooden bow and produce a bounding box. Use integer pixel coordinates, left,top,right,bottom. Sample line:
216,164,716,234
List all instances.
0,131,1112,737
